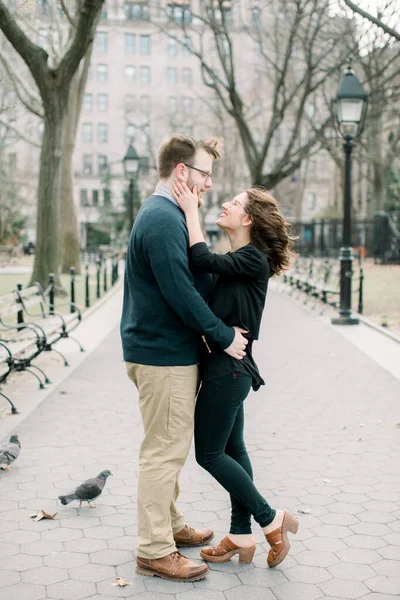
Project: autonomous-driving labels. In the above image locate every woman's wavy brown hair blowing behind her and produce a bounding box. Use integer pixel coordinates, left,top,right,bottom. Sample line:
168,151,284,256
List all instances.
244,187,297,277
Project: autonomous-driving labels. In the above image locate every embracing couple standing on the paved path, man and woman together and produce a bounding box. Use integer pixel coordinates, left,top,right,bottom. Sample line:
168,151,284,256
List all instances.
121,134,298,581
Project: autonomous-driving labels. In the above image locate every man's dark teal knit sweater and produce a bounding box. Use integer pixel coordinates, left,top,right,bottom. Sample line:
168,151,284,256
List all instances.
121,195,234,366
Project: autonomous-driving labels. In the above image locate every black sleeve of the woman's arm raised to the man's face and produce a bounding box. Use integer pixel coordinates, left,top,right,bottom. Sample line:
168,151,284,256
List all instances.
190,242,268,278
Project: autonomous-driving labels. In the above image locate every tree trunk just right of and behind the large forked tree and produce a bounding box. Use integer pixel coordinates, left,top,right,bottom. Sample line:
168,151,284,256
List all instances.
60,84,80,273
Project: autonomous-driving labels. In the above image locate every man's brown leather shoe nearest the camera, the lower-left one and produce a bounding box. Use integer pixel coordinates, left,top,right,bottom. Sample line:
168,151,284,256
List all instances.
136,552,209,582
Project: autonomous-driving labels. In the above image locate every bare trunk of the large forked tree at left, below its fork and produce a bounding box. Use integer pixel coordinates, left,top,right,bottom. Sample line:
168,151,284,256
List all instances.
30,94,66,290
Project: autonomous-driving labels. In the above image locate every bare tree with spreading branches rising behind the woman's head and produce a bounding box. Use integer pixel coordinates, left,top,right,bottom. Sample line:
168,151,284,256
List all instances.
159,0,354,188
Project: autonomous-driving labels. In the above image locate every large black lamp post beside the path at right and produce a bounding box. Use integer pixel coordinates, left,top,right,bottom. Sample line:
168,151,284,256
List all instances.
332,67,368,325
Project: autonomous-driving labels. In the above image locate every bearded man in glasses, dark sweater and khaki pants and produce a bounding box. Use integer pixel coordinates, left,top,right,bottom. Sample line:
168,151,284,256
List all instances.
121,134,247,581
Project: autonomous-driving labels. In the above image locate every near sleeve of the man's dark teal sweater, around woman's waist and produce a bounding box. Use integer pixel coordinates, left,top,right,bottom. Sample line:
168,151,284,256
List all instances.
146,215,235,349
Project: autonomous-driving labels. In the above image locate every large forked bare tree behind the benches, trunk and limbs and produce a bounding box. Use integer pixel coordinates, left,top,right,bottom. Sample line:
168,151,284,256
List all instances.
0,0,103,288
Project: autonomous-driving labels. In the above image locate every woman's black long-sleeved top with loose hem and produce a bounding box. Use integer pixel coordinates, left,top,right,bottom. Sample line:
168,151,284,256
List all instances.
190,242,270,390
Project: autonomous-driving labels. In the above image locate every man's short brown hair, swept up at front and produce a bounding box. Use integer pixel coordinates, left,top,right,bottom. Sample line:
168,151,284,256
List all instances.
158,133,223,179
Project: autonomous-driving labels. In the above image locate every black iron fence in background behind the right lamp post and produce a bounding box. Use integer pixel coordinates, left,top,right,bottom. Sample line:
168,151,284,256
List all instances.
292,213,400,263
